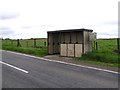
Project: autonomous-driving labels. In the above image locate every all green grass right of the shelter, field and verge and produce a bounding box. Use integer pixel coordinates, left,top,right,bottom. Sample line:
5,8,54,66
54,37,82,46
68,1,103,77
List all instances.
80,39,120,67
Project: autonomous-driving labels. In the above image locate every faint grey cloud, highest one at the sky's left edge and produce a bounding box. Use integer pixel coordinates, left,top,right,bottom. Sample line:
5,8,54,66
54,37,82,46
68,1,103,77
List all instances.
0,12,19,20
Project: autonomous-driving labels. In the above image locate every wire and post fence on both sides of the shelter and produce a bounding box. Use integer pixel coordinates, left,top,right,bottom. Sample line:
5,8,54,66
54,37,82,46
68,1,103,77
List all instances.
2,38,120,53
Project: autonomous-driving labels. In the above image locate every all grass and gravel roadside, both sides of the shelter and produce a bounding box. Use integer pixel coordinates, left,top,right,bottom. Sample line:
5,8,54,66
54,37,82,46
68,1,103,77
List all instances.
2,39,120,71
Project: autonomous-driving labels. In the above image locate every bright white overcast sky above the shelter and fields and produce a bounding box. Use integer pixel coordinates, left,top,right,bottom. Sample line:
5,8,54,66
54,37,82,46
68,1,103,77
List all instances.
0,0,119,39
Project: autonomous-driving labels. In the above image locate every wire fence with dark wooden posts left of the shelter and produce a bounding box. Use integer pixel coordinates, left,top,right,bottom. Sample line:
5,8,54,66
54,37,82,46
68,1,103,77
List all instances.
2,39,47,48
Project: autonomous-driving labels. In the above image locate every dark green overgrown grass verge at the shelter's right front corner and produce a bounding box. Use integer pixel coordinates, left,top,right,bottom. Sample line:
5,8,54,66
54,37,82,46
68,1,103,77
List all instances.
80,52,120,67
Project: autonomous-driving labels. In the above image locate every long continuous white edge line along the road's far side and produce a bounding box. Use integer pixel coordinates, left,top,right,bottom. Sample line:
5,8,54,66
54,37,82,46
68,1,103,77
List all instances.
4,50,119,74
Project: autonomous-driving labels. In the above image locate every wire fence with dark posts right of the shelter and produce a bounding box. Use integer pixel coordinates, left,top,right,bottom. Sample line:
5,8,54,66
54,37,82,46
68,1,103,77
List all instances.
92,38,120,53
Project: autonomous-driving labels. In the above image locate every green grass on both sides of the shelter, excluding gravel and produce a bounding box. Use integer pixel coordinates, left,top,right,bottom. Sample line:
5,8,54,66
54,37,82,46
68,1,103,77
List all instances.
2,38,120,67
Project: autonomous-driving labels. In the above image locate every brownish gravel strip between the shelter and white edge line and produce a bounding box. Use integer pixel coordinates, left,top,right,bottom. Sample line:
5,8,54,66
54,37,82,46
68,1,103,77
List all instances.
43,55,118,72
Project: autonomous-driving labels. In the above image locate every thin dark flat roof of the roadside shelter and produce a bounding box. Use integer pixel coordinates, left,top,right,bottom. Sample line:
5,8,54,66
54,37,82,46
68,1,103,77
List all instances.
47,28,93,33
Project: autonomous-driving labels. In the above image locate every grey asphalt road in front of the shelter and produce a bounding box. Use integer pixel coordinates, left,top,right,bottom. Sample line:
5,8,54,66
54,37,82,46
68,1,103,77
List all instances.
2,51,118,88
